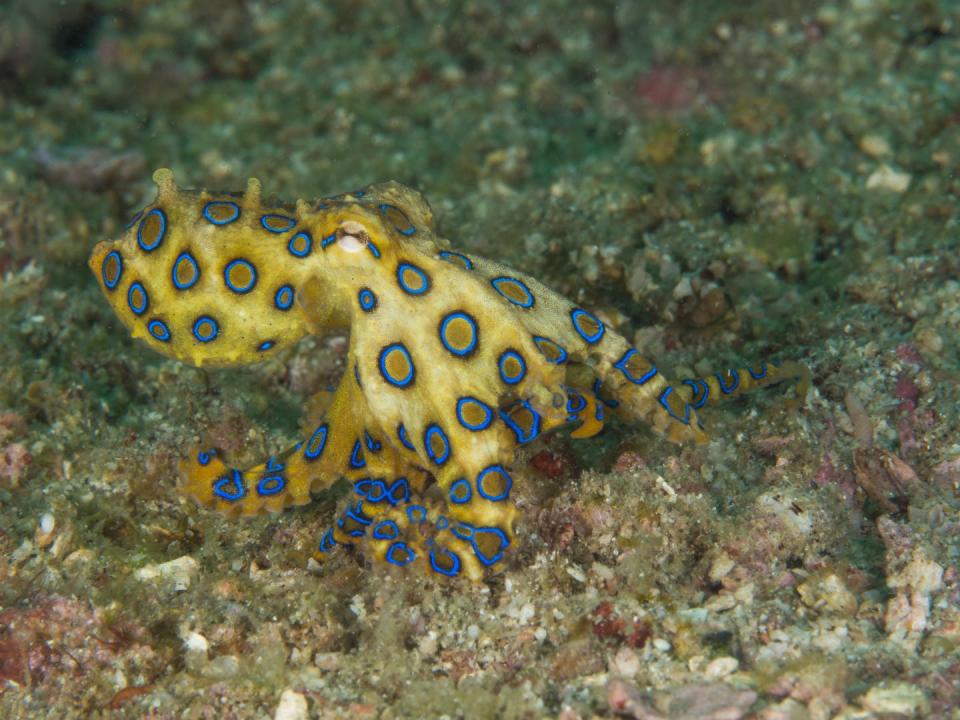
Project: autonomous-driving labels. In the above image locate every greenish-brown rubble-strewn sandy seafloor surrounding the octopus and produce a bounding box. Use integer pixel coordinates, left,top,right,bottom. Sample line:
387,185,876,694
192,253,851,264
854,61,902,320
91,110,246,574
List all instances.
0,0,960,720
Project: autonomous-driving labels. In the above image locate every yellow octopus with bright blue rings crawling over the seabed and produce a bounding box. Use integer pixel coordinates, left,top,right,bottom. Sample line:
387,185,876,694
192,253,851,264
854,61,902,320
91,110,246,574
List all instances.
90,170,809,579
